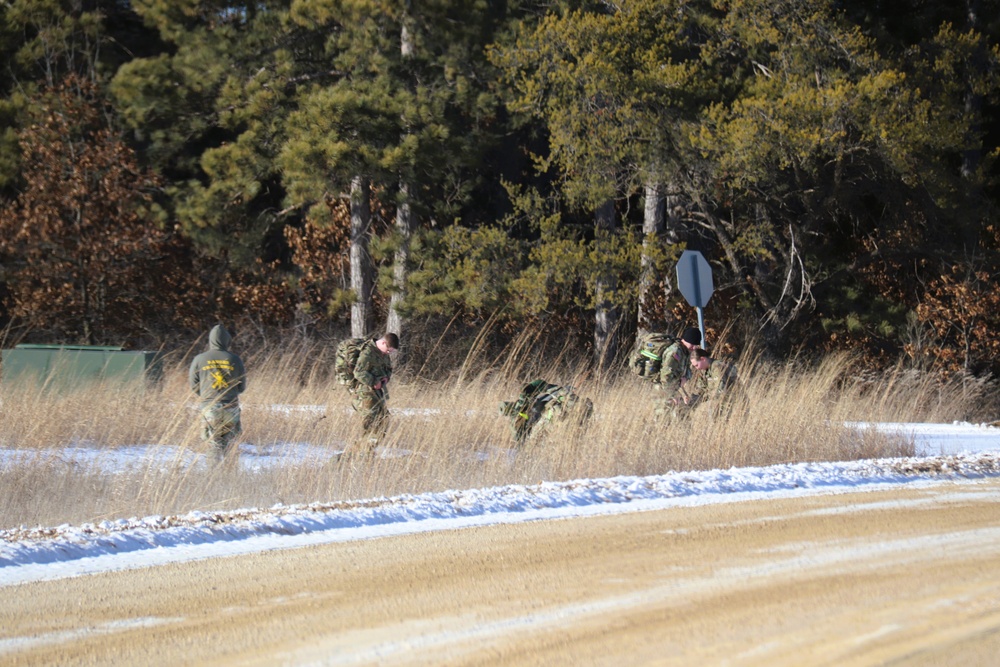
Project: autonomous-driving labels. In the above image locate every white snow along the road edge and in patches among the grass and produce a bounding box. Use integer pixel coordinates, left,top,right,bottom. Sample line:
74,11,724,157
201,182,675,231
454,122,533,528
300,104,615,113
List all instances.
0,423,1000,586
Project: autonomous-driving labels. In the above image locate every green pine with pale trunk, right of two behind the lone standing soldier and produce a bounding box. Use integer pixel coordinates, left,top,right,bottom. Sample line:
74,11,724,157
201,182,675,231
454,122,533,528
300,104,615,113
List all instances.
281,0,508,345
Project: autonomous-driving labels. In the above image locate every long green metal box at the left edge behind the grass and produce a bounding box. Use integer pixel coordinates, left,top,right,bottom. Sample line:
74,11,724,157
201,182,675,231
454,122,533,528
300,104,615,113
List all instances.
0,345,163,390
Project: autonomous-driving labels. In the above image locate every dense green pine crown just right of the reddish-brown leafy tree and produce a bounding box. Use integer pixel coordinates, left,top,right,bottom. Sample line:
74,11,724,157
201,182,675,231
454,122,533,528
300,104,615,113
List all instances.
112,0,326,270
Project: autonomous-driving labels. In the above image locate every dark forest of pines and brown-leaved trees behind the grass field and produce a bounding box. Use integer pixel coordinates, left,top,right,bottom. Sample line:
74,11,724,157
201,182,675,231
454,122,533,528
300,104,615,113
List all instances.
0,0,1000,377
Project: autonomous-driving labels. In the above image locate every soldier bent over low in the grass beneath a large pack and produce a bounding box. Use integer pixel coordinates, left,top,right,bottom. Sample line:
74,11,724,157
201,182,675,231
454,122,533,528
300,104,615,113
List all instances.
500,380,594,447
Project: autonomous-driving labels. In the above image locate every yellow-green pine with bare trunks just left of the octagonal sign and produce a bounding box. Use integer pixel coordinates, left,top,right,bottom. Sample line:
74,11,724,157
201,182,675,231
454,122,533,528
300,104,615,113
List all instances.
491,0,714,363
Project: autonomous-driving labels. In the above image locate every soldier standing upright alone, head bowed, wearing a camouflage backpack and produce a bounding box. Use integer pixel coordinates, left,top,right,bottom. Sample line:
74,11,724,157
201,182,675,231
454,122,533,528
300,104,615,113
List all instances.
348,333,399,454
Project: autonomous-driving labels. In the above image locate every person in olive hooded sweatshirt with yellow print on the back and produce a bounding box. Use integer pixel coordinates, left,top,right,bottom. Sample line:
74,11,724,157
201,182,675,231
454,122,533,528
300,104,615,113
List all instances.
188,324,247,461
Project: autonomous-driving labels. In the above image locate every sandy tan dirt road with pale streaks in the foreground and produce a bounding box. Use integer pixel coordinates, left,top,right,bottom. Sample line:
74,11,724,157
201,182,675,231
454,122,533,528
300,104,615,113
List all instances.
0,479,1000,667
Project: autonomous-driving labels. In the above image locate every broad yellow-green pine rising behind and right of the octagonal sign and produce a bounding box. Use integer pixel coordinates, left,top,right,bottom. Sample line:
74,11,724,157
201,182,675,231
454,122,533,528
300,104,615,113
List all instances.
695,0,996,350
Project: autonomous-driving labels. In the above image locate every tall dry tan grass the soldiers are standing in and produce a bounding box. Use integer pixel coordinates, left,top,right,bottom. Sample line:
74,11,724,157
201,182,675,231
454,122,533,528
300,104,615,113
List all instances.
0,334,988,528
